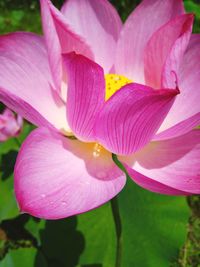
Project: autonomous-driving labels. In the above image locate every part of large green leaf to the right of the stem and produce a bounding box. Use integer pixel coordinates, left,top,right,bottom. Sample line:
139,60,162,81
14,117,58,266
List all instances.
119,179,189,267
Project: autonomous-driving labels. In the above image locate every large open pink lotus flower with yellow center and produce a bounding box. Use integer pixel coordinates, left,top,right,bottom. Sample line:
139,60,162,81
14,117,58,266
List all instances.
0,0,200,219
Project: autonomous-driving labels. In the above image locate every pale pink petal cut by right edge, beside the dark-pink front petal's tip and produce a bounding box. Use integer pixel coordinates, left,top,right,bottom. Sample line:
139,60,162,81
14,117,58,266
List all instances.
156,34,200,139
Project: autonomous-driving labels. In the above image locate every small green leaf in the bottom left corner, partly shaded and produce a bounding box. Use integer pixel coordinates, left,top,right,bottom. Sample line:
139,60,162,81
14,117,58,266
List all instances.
0,248,48,267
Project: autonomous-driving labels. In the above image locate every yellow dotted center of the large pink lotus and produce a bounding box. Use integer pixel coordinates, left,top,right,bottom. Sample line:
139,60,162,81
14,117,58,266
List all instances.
105,74,133,100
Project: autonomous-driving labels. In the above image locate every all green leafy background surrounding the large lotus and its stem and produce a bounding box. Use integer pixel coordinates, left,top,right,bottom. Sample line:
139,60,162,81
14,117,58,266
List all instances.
0,0,200,267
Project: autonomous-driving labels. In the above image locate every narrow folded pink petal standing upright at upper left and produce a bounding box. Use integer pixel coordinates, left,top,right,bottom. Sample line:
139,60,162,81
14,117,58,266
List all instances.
40,0,93,91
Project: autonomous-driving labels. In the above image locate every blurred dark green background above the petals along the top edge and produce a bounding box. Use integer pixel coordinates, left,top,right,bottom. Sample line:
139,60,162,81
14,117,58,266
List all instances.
0,0,200,34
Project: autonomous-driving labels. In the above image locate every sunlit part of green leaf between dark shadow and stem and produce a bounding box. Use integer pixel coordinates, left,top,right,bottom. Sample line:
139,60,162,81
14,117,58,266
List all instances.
78,203,116,267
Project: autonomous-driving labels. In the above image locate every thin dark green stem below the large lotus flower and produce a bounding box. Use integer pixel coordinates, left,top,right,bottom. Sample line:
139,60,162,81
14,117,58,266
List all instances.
111,196,122,267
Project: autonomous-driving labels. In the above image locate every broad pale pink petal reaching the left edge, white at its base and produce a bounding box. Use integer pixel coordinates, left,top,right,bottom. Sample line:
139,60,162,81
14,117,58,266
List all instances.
0,33,67,132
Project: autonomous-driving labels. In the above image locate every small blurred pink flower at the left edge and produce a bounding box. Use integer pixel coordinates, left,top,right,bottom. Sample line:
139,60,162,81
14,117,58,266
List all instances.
0,108,23,142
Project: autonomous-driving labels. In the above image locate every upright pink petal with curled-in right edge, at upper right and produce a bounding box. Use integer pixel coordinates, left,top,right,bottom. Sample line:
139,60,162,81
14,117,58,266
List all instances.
144,14,193,88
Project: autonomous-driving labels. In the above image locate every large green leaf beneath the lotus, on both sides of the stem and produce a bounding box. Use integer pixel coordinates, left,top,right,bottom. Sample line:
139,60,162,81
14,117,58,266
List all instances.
22,179,189,267
